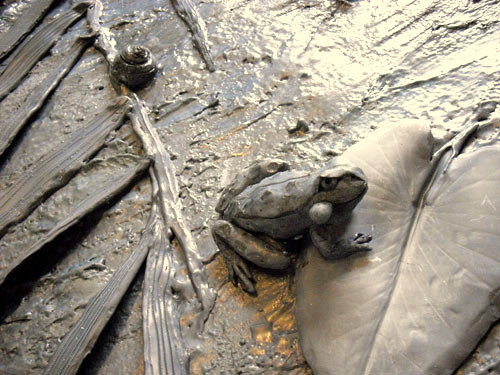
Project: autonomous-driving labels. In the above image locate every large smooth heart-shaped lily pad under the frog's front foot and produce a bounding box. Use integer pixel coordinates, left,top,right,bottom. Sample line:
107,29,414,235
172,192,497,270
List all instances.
296,123,500,375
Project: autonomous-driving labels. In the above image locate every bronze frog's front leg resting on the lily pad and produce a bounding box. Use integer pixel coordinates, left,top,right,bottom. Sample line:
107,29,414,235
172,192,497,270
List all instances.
310,225,372,260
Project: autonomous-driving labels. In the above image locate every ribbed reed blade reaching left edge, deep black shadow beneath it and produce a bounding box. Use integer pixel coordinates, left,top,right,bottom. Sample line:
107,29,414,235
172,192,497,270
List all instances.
0,155,149,285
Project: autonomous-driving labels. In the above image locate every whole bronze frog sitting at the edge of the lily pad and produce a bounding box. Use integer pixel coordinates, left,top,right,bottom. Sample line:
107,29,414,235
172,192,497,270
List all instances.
211,156,372,295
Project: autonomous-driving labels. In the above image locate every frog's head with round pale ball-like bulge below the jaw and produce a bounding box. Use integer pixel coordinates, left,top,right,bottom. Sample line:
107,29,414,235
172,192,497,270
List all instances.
309,163,368,224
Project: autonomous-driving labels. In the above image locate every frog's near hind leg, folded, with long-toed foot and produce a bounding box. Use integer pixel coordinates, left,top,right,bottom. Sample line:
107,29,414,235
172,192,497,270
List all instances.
212,220,291,295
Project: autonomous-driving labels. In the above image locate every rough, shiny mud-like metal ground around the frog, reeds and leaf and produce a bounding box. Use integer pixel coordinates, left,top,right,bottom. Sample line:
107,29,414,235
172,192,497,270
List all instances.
0,0,500,375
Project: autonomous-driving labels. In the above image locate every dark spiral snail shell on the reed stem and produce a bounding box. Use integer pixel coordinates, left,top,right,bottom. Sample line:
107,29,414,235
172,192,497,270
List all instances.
111,45,158,90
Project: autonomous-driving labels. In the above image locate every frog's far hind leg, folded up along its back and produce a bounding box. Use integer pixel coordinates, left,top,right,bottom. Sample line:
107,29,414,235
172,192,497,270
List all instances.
215,159,290,213
